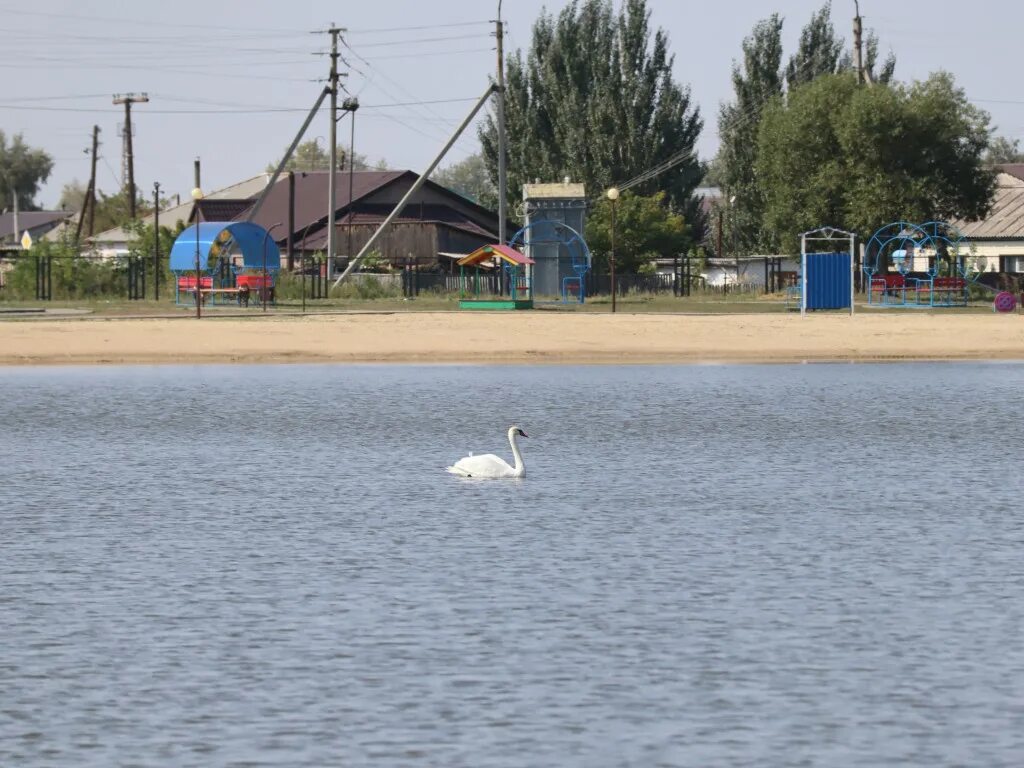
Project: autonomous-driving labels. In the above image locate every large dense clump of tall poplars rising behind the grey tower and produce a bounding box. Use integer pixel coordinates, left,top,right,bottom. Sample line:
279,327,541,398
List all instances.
479,0,703,221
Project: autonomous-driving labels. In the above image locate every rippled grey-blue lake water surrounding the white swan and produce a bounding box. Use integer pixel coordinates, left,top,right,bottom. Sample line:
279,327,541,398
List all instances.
0,365,1024,768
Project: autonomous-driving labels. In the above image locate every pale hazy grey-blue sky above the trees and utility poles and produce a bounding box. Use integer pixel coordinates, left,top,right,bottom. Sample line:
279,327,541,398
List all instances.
0,0,1024,207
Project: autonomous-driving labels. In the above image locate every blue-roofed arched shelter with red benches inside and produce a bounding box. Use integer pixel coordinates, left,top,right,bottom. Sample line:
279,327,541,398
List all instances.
170,221,281,306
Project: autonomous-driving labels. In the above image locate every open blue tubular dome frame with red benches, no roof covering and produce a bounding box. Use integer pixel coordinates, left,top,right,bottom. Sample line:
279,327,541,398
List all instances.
863,221,974,309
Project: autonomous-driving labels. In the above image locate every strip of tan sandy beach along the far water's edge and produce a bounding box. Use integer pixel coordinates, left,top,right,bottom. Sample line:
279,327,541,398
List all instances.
0,312,1024,366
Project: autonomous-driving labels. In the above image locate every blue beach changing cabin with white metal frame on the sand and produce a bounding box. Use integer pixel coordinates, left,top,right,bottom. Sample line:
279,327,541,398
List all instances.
786,226,857,315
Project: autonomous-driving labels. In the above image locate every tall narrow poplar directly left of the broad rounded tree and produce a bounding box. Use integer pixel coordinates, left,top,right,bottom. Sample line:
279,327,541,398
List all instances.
717,13,782,256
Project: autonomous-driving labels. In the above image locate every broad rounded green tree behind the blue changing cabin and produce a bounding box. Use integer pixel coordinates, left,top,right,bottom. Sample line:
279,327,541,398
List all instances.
755,73,994,252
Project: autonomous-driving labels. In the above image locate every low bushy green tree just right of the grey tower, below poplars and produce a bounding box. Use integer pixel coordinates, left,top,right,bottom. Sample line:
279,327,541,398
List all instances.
585,191,691,272
